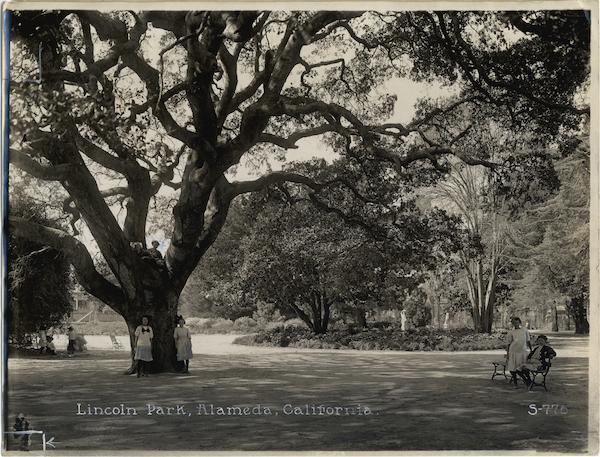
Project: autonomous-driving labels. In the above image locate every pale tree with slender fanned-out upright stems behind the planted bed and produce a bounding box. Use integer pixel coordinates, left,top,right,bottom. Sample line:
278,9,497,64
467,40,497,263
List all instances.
427,99,558,333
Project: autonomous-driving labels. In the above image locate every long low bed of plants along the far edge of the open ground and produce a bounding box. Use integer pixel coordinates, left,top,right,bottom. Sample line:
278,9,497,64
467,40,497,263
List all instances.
234,324,506,351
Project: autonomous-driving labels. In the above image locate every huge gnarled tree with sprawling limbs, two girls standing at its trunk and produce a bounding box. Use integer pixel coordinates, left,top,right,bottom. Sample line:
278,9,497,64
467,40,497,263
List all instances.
9,10,589,369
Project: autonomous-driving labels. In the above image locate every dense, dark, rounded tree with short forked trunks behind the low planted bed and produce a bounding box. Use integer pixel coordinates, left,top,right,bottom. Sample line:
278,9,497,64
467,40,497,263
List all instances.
239,189,458,333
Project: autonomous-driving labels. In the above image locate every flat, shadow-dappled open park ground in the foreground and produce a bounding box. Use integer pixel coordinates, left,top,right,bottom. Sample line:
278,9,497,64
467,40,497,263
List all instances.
2,334,588,454
